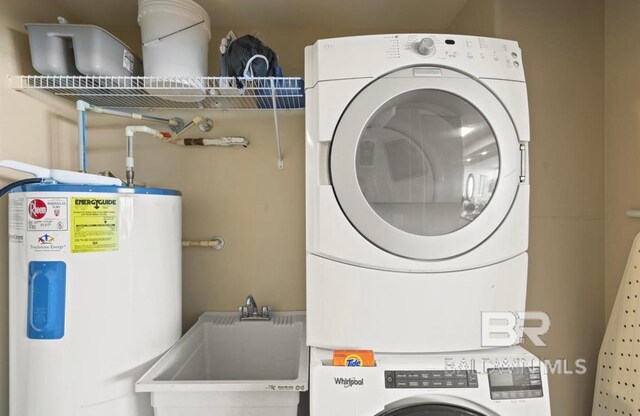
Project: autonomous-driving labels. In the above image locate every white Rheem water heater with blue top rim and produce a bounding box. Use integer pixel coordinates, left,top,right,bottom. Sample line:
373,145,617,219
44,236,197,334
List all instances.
9,184,182,416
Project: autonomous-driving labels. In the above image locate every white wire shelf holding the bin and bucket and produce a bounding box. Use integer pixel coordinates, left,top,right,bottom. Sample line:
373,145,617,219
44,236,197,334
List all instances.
9,75,304,110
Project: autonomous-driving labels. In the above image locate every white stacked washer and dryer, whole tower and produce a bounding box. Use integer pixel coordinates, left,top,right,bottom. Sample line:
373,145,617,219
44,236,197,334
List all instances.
305,34,550,416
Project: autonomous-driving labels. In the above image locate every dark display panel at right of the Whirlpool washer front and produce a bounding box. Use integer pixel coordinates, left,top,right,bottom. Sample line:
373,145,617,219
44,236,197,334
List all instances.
488,367,543,400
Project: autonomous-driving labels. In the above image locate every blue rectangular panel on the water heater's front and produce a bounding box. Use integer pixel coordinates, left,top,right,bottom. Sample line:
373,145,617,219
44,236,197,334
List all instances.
27,261,67,339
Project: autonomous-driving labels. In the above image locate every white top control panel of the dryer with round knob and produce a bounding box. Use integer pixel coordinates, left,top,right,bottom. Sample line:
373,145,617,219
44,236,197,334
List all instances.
305,33,525,87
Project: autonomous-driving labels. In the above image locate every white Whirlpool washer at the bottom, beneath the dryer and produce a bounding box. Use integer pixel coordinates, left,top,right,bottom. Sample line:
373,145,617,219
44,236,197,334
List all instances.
310,347,551,416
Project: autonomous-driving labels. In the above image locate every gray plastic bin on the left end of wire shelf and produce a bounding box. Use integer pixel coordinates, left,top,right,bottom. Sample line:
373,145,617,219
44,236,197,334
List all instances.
25,23,143,76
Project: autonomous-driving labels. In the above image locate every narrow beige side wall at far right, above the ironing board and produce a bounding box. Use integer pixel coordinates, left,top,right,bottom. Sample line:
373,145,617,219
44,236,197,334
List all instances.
605,0,640,317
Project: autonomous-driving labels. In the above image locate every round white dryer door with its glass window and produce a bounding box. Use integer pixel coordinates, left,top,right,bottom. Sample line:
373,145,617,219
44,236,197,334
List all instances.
330,67,523,260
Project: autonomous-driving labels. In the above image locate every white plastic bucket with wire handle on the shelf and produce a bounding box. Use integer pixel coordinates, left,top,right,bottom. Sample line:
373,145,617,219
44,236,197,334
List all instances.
138,0,211,101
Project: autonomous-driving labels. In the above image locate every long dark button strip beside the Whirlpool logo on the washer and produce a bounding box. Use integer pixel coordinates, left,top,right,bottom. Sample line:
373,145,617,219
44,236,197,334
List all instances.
384,370,478,389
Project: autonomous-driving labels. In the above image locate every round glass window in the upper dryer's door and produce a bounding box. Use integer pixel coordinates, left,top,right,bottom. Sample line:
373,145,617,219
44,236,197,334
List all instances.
355,89,500,236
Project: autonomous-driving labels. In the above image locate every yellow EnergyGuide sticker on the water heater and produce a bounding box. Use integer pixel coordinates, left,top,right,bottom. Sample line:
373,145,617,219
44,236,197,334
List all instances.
71,198,119,253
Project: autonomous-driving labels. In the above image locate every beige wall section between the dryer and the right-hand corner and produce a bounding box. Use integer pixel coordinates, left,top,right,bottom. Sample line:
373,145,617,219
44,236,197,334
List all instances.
452,0,608,416
